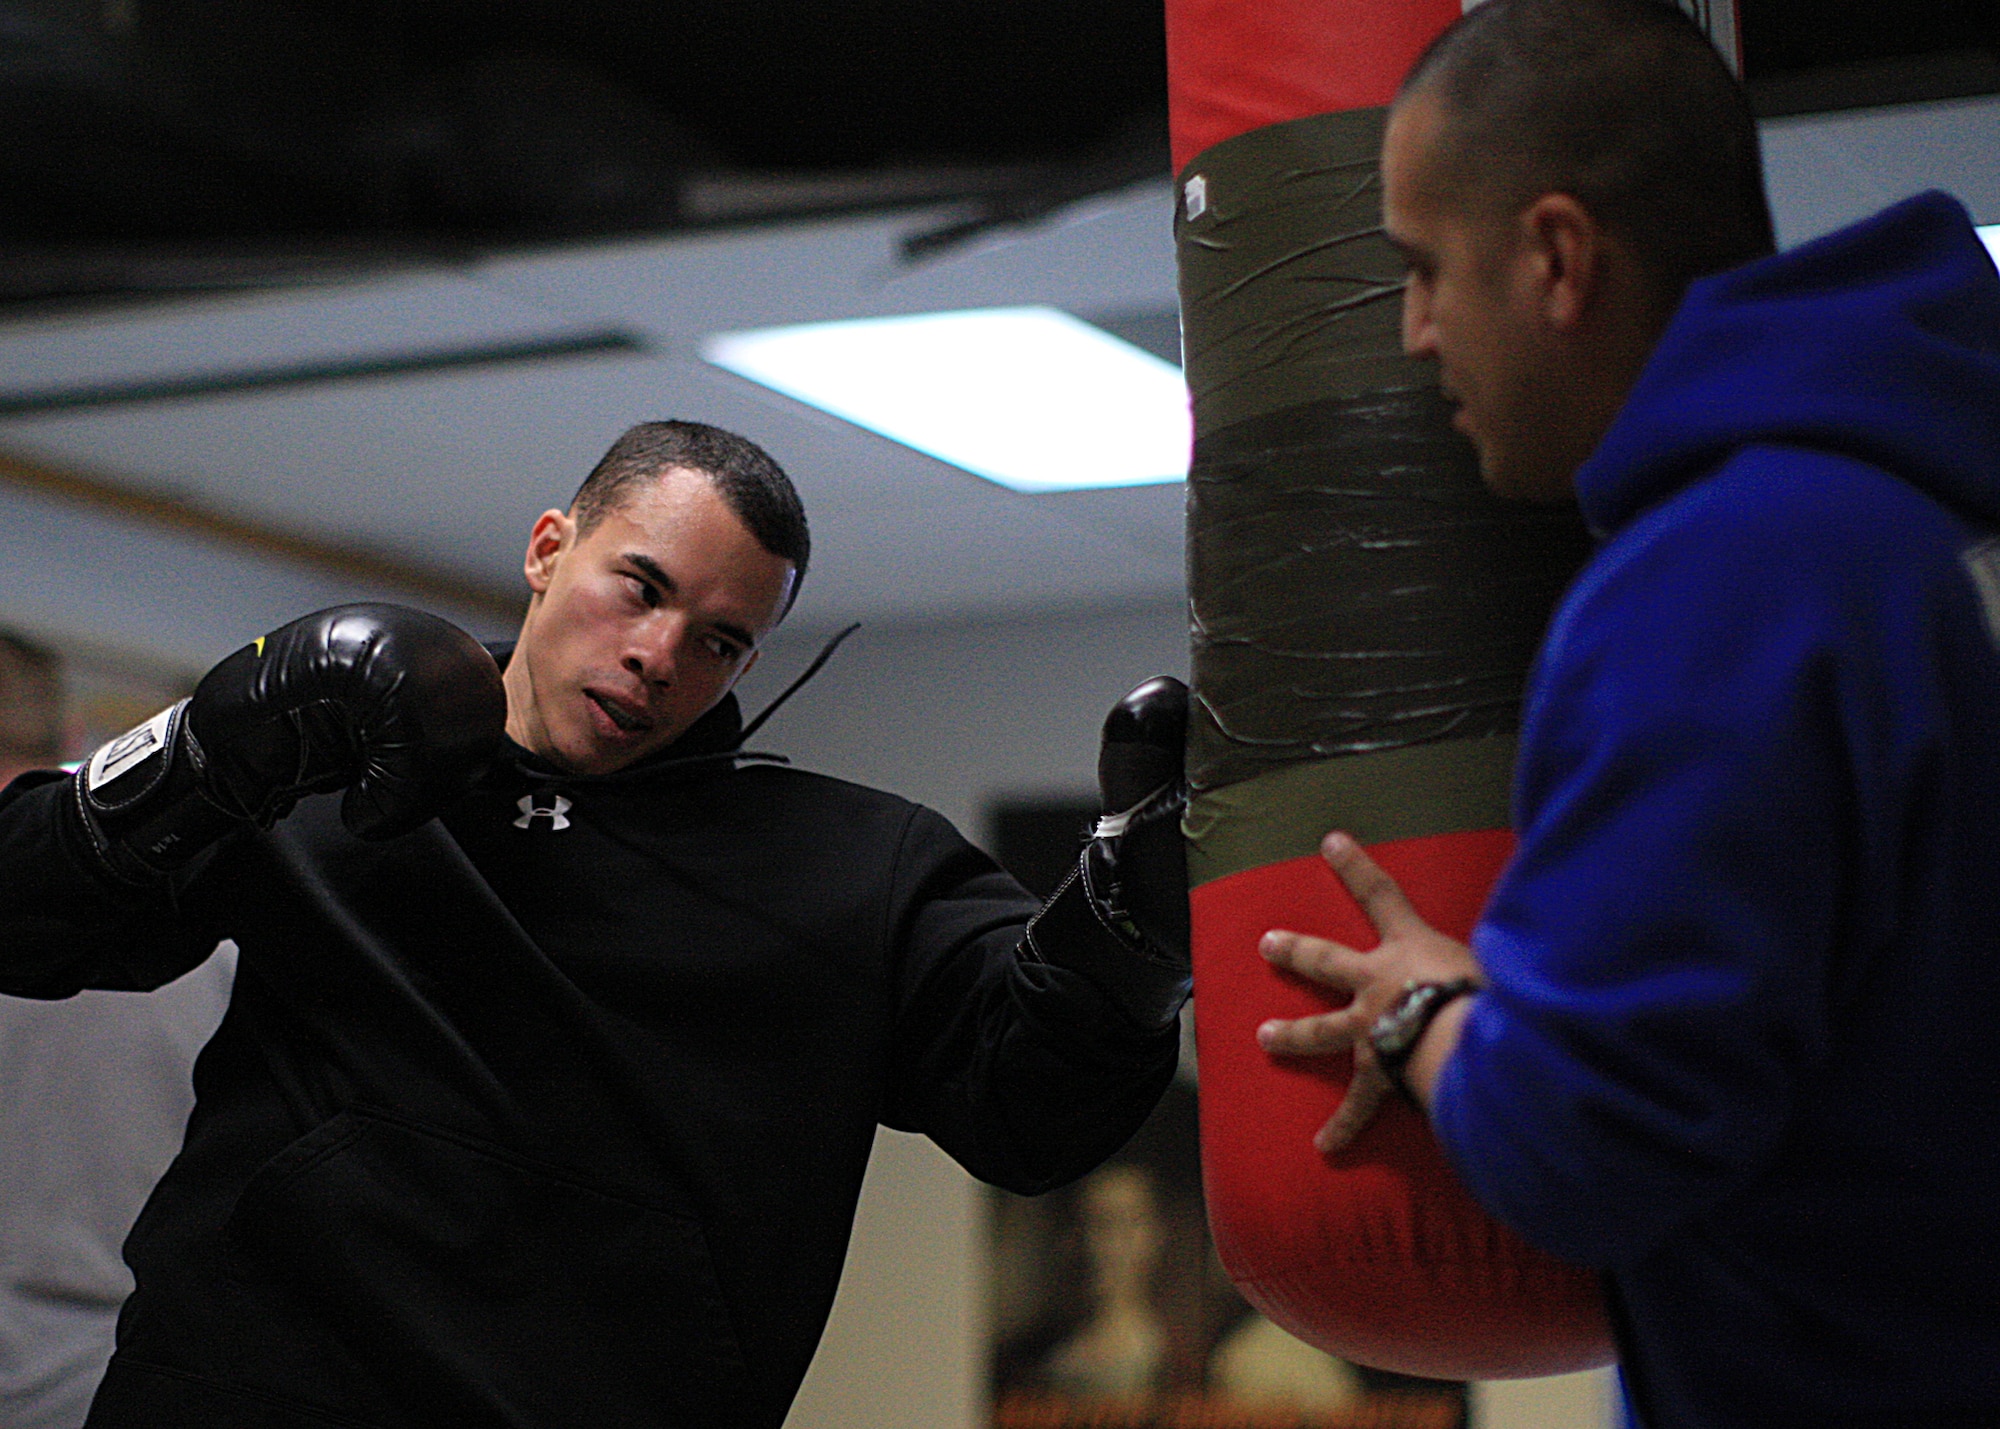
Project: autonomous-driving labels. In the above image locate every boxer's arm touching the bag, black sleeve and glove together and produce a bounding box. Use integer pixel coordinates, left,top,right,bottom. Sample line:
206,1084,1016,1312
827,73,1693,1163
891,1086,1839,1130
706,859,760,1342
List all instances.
884,678,1190,1193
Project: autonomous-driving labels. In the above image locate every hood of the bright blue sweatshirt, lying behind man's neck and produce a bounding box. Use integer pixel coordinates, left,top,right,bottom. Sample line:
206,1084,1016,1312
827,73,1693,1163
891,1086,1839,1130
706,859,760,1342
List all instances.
1576,192,2000,536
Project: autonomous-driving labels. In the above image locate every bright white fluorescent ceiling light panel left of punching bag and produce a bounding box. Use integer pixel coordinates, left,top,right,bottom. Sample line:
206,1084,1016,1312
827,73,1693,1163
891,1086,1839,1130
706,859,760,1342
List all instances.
702,308,1192,490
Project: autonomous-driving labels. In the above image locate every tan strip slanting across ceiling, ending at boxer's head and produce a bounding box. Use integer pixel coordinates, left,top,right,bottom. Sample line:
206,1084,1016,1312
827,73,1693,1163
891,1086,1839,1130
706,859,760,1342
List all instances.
0,450,524,622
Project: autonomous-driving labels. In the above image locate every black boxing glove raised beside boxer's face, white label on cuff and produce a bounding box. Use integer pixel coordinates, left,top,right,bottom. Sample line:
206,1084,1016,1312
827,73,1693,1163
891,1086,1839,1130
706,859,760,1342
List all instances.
68,604,506,885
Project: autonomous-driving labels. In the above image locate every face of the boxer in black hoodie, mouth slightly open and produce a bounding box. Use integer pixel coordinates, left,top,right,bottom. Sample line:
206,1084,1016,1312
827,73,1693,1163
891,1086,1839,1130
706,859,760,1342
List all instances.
506,470,794,775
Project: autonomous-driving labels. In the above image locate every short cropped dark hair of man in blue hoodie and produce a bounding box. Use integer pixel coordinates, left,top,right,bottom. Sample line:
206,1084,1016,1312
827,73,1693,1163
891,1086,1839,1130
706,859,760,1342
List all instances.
1396,0,1776,310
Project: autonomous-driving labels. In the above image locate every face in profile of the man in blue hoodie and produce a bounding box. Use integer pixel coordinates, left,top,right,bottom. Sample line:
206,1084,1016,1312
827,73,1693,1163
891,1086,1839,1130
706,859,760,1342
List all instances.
1382,92,1574,500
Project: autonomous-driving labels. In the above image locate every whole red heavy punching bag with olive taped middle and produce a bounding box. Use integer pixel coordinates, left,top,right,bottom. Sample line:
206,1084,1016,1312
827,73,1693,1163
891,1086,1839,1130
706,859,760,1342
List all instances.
1168,0,1612,1379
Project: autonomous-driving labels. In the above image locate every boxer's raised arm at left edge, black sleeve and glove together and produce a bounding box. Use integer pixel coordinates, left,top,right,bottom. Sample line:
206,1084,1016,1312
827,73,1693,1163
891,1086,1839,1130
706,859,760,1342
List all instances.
0,604,506,997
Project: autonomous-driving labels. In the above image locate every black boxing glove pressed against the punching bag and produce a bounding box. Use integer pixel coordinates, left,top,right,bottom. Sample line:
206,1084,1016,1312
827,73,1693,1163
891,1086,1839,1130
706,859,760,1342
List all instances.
1024,674,1192,1027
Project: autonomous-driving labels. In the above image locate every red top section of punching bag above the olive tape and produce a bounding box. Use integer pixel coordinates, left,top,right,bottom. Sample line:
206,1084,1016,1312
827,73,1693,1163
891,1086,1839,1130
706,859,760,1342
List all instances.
1166,0,1460,174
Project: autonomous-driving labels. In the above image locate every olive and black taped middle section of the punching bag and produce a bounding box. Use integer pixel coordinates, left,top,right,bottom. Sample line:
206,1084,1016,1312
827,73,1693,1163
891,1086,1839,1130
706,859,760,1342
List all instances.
1174,110,1588,883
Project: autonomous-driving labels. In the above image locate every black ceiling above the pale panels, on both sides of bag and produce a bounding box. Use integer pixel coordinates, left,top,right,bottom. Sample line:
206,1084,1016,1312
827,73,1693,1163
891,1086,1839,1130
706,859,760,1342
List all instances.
0,0,2000,304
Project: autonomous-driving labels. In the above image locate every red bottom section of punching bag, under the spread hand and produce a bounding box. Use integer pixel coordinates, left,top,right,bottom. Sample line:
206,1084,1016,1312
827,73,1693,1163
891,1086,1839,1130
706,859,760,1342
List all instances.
1194,829,1614,1379
